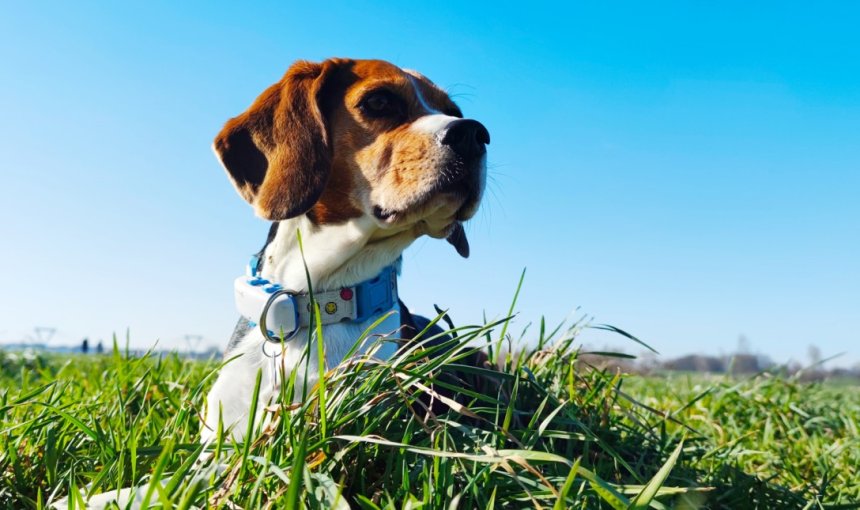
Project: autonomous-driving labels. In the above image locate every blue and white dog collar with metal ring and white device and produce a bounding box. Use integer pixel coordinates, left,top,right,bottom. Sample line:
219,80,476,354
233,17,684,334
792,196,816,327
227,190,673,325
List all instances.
233,256,400,342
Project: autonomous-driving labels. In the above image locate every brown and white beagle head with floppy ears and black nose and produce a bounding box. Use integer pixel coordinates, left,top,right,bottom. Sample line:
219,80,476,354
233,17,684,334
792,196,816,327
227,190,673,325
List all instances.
214,59,490,257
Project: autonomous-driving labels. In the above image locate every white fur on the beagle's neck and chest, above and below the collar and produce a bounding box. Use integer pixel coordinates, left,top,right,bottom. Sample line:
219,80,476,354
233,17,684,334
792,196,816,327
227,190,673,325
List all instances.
201,211,413,442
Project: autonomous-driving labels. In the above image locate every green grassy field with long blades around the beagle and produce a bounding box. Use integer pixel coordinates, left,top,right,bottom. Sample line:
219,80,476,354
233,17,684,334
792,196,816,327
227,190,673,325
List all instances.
0,316,860,509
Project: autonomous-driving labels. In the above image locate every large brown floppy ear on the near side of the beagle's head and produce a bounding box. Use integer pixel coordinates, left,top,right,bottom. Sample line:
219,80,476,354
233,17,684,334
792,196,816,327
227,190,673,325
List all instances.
214,61,337,221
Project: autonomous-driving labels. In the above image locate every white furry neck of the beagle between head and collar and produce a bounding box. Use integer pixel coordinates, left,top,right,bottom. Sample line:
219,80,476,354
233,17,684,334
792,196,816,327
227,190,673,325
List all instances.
261,215,415,292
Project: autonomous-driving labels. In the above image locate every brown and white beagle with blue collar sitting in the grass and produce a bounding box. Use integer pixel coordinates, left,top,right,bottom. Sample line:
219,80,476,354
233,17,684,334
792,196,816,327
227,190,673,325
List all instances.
201,58,490,442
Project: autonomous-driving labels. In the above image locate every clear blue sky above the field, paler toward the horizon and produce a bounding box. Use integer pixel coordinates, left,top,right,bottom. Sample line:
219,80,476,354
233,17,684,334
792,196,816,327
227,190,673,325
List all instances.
0,2,860,365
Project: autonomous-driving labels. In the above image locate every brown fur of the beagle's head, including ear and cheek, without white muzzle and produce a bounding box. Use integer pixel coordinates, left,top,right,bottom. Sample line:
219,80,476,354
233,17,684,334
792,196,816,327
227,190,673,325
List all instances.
215,59,470,224
